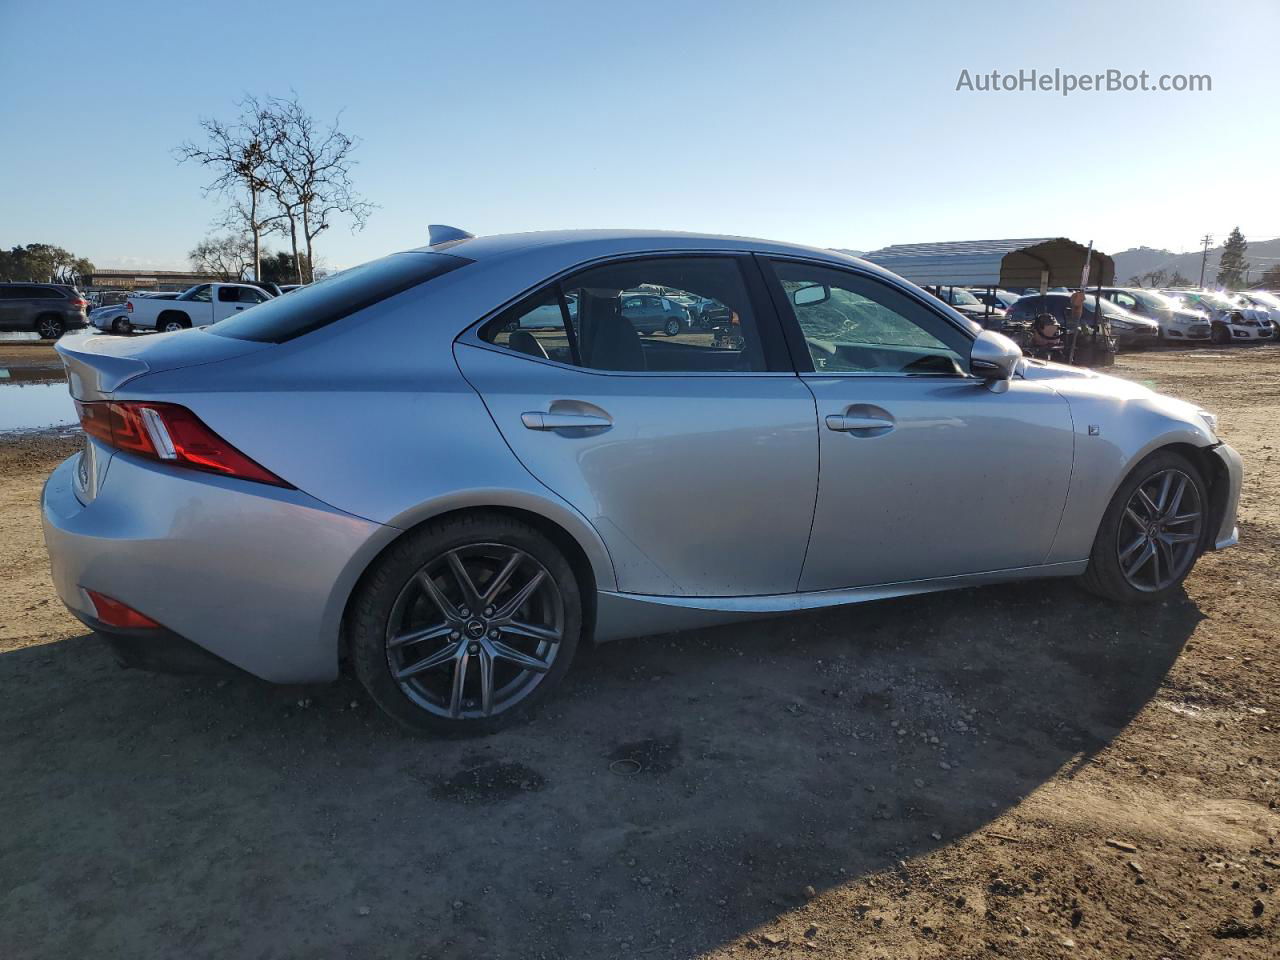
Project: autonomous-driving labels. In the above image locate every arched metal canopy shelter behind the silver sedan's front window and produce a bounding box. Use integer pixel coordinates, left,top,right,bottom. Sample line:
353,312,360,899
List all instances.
863,237,1116,288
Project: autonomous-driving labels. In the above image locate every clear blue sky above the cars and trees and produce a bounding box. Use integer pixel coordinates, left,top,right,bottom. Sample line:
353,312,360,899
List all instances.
0,0,1280,268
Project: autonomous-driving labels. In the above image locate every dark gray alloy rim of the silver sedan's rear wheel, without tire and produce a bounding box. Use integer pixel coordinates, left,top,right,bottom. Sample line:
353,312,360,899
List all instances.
385,543,564,721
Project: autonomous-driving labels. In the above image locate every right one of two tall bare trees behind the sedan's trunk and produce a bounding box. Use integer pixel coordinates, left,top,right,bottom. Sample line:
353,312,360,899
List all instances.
268,95,375,283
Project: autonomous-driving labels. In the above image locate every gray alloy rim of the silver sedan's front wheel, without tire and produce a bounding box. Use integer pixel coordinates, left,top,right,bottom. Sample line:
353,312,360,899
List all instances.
1115,467,1204,593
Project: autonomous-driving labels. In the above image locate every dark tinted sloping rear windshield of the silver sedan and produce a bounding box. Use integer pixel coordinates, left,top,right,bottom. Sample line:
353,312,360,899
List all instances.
209,251,471,343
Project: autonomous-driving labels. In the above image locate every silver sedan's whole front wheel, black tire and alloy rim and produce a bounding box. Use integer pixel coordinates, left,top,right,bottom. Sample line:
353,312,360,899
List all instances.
1082,451,1208,603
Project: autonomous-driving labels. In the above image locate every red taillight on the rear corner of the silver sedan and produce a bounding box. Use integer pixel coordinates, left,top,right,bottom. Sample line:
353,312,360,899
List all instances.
76,401,292,488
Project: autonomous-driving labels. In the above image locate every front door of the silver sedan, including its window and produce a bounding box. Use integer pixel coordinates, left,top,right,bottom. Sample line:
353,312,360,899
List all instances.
757,260,1074,590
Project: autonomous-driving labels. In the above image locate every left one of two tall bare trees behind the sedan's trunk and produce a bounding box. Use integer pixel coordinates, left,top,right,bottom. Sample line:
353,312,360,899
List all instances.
175,96,280,285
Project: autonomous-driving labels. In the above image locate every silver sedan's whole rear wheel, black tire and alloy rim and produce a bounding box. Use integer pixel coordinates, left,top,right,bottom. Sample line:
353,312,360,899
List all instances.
347,513,582,735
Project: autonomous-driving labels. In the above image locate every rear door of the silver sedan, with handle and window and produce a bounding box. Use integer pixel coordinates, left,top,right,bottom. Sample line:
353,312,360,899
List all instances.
456,255,818,596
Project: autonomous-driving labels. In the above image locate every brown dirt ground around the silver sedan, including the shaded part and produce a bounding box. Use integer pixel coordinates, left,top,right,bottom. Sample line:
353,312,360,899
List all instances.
0,347,1280,960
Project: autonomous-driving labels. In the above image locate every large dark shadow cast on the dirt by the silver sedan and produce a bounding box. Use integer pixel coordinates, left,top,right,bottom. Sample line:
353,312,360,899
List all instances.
0,582,1201,957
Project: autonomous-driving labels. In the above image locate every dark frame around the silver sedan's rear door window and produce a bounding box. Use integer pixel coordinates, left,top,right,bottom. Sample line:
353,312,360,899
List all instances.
453,250,800,380
